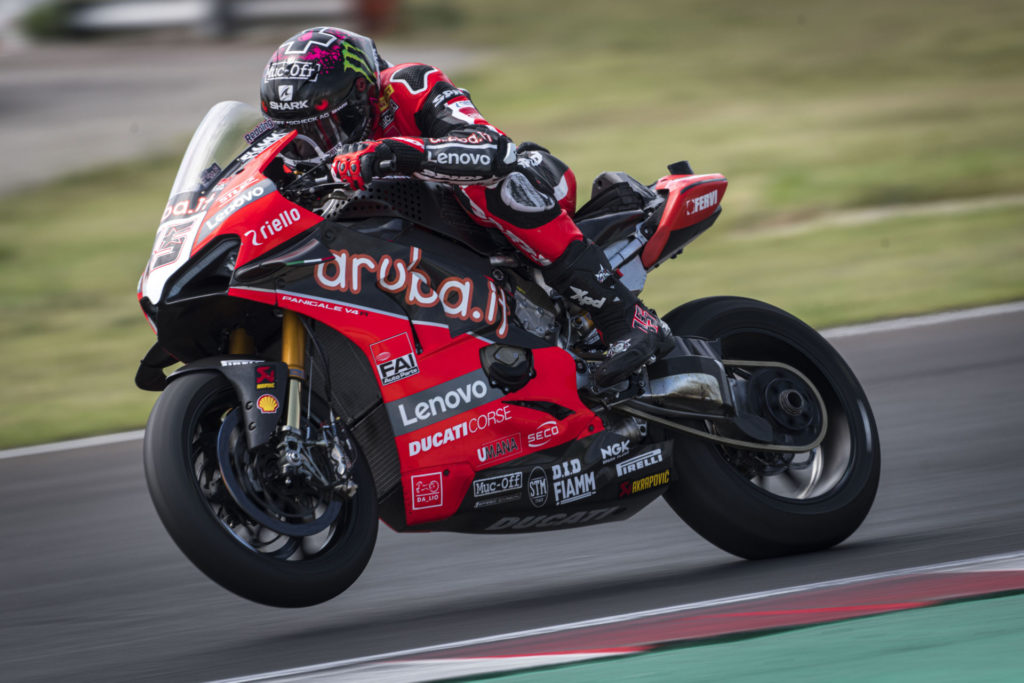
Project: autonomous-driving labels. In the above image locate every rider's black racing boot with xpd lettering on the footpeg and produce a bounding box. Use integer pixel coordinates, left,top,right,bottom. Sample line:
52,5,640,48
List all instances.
544,240,676,387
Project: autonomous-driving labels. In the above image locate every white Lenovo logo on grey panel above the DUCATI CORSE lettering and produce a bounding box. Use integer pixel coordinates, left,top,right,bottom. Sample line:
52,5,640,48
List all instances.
387,370,504,435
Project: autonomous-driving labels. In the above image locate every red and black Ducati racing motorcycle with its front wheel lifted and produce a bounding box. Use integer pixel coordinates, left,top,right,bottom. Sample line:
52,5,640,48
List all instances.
136,102,880,606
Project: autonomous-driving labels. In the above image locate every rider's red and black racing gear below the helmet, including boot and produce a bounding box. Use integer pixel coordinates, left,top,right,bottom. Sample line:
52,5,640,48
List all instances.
332,63,673,386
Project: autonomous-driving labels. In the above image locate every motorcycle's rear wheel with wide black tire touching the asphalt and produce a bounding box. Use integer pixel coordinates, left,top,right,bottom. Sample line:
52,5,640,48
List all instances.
664,297,881,559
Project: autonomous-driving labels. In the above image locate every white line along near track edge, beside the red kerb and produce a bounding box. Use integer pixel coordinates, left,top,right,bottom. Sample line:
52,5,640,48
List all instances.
207,551,1024,683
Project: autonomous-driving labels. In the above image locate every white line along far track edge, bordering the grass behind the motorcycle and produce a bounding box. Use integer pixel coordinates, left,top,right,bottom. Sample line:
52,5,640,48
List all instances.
0,301,1024,460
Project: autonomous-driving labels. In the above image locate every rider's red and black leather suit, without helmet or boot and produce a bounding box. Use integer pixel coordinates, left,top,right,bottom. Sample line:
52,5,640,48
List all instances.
348,63,583,265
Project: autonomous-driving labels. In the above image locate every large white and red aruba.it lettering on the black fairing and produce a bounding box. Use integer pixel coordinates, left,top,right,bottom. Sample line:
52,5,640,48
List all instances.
314,247,509,338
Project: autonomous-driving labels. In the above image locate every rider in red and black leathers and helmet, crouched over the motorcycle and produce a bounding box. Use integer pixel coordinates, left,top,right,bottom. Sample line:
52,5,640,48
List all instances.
260,27,675,386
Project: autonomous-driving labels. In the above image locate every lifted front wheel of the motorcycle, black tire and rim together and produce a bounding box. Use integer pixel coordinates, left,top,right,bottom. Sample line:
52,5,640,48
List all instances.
144,373,377,607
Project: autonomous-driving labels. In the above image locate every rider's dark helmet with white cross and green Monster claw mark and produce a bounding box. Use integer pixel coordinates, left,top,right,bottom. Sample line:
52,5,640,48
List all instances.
259,27,387,154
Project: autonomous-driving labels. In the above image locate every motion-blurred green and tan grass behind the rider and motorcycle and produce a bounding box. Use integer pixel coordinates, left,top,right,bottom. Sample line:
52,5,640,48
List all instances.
0,0,1024,447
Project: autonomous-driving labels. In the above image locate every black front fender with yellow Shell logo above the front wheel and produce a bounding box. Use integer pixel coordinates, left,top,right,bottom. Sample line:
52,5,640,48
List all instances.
167,355,288,449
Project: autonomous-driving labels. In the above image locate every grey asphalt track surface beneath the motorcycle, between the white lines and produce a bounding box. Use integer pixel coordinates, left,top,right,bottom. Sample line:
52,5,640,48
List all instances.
0,306,1024,681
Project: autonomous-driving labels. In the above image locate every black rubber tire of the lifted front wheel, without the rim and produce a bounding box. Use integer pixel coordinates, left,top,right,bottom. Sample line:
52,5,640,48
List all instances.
144,373,377,607
